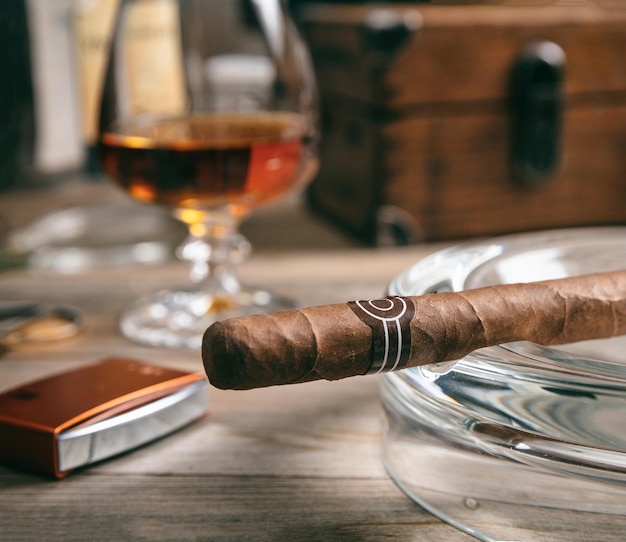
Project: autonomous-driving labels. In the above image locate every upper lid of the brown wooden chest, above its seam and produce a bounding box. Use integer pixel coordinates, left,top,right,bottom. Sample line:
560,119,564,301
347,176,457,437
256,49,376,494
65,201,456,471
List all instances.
302,0,626,107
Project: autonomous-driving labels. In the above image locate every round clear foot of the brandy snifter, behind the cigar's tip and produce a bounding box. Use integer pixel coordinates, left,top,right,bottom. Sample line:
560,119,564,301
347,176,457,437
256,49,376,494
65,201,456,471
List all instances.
120,290,295,350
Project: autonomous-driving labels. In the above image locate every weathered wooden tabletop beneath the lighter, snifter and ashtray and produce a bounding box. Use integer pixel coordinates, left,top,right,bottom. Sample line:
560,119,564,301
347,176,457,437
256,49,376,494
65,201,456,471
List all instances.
0,181,471,541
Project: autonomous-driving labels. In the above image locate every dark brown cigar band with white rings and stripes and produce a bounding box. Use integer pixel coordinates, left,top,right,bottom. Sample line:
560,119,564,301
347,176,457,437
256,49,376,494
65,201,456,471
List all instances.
348,296,415,374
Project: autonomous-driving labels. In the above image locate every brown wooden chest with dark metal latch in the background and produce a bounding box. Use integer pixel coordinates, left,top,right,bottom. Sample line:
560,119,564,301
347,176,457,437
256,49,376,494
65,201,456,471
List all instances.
301,0,626,244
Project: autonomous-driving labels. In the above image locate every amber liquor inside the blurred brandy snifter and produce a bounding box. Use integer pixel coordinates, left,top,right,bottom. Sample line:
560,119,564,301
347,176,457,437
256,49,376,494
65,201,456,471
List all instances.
100,113,307,214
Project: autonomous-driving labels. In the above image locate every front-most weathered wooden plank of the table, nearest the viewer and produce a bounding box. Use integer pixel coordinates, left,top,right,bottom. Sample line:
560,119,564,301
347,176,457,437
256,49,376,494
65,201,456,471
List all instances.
0,472,471,542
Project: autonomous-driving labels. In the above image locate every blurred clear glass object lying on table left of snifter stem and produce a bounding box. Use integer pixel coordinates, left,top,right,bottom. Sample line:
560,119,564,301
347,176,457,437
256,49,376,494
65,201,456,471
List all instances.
6,203,185,273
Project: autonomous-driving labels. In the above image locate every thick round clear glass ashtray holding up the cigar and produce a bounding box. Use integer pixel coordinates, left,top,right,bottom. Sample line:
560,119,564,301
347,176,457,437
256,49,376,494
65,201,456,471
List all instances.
381,227,626,542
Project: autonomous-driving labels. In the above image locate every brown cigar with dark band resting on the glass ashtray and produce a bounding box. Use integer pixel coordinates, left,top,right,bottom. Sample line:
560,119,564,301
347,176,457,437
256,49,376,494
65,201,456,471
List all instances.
202,271,626,389
